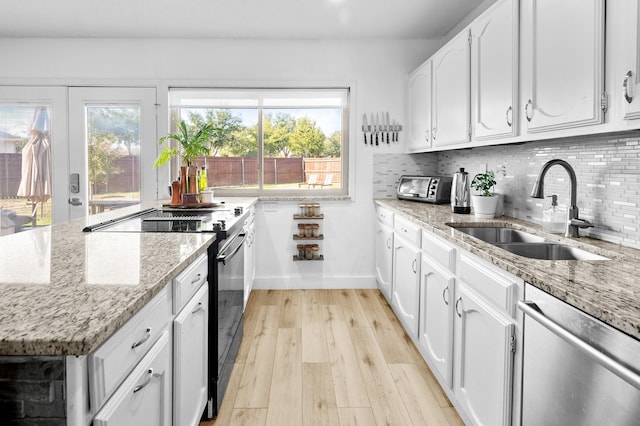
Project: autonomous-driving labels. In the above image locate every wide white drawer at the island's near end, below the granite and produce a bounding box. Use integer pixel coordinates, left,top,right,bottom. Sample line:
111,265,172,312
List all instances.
87,286,172,409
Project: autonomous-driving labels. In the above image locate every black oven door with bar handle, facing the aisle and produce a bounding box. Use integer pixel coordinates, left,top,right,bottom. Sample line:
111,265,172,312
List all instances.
215,231,247,413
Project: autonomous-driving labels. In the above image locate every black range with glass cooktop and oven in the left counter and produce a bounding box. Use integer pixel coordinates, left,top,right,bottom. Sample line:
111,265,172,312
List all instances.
84,205,248,418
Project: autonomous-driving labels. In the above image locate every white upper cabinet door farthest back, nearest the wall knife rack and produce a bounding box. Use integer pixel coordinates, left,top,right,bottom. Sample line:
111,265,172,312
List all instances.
407,60,431,151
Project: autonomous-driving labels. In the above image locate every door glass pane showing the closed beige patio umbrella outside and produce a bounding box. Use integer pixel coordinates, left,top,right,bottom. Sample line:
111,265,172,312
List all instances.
0,104,53,235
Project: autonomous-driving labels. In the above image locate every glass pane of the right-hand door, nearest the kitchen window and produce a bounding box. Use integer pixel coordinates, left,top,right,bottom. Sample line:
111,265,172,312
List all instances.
86,105,140,214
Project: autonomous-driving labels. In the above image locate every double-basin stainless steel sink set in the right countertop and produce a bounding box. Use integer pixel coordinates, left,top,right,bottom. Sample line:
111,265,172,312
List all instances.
449,225,607,260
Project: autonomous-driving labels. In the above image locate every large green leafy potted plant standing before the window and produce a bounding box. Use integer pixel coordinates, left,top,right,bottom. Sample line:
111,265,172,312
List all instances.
153,120,215,194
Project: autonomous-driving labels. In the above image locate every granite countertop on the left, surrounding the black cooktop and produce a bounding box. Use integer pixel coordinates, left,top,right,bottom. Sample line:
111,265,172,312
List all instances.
0,198,257,355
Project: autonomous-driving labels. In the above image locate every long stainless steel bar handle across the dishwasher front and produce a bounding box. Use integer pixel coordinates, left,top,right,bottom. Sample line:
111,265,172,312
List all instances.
518,300,640,389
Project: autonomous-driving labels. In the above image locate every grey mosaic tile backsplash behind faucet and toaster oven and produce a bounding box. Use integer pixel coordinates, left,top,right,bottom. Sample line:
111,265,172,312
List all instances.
373,132,640,248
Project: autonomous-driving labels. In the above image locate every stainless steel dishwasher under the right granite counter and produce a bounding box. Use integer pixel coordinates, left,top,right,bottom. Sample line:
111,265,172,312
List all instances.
518,284,640,426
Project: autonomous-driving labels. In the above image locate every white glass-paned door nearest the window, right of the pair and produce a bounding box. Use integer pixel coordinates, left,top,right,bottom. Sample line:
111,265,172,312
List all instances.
67,87,157,219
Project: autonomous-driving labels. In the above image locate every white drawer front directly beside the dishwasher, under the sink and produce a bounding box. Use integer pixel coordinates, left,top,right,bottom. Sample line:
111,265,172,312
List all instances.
458,253,521,317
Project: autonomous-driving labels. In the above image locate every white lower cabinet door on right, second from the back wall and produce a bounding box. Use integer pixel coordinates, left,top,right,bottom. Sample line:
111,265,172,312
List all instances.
391,235,420,337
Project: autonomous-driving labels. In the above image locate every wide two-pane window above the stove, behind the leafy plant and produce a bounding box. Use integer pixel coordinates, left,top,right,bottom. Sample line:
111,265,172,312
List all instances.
169,88,349,196
